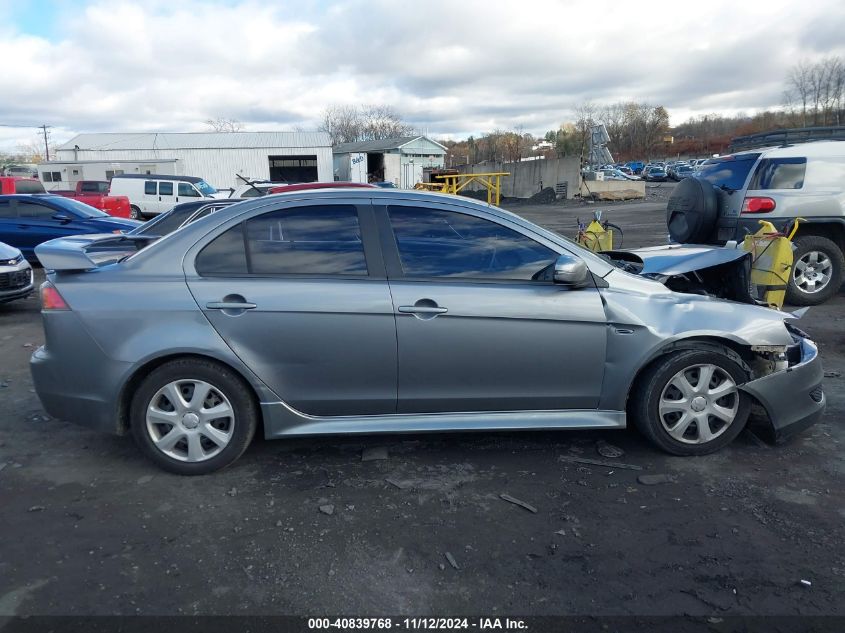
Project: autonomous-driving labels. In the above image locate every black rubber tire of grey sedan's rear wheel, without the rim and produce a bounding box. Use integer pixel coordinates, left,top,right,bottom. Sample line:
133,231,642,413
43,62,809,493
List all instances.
130,358,259,475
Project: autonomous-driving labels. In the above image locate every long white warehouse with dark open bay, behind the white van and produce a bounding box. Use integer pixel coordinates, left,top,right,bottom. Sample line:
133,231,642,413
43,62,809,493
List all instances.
43,132,333,190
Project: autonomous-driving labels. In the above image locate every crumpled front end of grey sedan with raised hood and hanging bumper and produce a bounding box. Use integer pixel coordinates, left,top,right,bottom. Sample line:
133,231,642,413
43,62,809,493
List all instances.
603,245,826,442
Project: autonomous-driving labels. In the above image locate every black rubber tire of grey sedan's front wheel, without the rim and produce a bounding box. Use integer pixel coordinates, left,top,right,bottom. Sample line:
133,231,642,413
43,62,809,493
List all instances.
628,349,751,455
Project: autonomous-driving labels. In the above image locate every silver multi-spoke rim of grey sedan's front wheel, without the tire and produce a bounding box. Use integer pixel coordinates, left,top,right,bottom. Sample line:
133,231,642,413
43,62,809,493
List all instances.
658,364,739,444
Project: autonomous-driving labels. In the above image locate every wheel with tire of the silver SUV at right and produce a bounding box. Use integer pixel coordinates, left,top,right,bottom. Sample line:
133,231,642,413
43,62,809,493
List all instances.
786,235,845,306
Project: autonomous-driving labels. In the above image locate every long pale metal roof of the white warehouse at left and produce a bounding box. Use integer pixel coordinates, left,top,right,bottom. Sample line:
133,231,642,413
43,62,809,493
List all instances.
59,132,332,151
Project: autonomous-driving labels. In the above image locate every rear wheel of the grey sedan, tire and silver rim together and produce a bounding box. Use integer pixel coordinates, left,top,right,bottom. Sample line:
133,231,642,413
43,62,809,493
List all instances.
130,358,258,475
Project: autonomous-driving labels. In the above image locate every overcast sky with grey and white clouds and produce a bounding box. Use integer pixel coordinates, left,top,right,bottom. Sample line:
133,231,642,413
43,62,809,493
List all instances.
0,0,845,151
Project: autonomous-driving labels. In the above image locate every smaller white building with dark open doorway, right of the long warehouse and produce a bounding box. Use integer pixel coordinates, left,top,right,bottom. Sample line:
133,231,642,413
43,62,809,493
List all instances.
334,136,446,189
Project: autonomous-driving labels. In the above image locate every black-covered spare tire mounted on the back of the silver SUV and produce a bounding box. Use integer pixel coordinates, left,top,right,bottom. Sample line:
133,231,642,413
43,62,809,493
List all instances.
666,178,719,244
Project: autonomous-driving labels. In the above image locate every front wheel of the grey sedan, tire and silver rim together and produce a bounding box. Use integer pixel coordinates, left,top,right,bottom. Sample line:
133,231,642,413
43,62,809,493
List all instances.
629,350,751,455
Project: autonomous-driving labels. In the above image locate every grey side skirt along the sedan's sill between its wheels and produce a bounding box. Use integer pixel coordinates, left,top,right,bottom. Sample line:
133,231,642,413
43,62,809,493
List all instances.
261,402,626,439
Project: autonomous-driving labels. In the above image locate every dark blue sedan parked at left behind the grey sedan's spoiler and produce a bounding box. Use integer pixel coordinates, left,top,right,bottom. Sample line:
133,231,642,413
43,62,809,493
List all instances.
0,194,141,261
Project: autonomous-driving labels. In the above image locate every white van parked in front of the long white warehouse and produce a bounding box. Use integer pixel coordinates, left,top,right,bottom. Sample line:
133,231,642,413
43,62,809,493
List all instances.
109,174,219,220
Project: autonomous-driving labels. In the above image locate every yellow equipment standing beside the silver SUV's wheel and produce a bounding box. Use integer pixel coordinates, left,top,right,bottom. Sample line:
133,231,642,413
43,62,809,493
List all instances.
742,218,803,309
